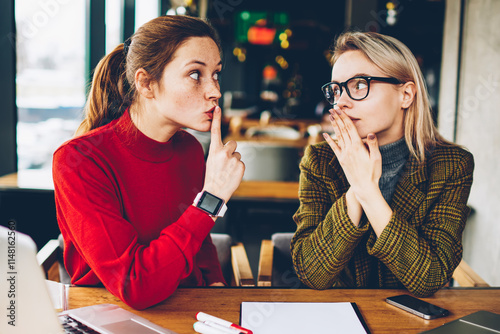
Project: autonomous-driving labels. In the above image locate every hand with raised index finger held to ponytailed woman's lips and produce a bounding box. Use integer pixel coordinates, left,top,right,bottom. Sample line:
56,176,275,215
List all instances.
203,106,245,202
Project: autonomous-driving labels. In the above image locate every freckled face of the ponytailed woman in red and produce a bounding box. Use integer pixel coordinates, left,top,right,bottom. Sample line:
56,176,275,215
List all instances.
154,37,222,131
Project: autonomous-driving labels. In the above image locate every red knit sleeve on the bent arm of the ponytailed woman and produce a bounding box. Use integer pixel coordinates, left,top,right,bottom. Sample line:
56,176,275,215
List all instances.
53,145,218,309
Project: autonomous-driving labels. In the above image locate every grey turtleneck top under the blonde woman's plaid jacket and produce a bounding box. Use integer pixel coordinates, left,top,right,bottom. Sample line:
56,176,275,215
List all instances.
378,137,410,204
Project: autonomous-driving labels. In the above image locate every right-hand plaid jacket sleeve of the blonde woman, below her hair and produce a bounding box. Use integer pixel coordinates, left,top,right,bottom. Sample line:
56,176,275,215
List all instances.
367,147,474,297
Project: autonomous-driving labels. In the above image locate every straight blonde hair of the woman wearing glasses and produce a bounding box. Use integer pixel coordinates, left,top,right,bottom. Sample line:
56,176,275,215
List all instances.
332,32,452,163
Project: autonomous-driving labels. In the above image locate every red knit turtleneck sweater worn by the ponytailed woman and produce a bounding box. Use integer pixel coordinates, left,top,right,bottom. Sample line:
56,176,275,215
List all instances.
53,112,224,309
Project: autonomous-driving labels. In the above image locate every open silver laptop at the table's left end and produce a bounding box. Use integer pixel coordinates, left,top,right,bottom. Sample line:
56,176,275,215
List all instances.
0,222,177,334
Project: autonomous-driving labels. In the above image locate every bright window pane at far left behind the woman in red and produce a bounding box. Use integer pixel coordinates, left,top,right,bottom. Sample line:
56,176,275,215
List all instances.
15,0,85,170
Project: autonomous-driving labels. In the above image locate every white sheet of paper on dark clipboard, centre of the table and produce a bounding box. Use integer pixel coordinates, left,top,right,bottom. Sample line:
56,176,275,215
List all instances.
240,302,370,334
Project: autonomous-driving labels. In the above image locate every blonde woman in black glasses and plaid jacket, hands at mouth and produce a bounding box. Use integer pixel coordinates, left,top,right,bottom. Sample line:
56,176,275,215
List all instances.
292,32,474,297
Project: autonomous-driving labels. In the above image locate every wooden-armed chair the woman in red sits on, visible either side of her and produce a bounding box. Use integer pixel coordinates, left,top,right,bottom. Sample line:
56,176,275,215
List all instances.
37,233,255,287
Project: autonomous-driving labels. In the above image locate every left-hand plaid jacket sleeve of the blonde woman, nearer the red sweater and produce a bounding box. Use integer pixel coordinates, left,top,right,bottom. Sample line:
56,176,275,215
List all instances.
291,146,369,289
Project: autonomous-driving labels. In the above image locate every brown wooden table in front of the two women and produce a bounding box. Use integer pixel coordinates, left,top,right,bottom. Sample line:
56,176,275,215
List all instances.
69,287,500,334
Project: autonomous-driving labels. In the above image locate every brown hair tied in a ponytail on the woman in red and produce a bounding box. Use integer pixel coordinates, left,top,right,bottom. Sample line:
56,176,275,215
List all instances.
76,16,222,135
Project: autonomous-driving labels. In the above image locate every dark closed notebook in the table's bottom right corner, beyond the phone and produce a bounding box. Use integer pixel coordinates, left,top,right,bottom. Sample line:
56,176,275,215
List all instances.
422,311,500,334
